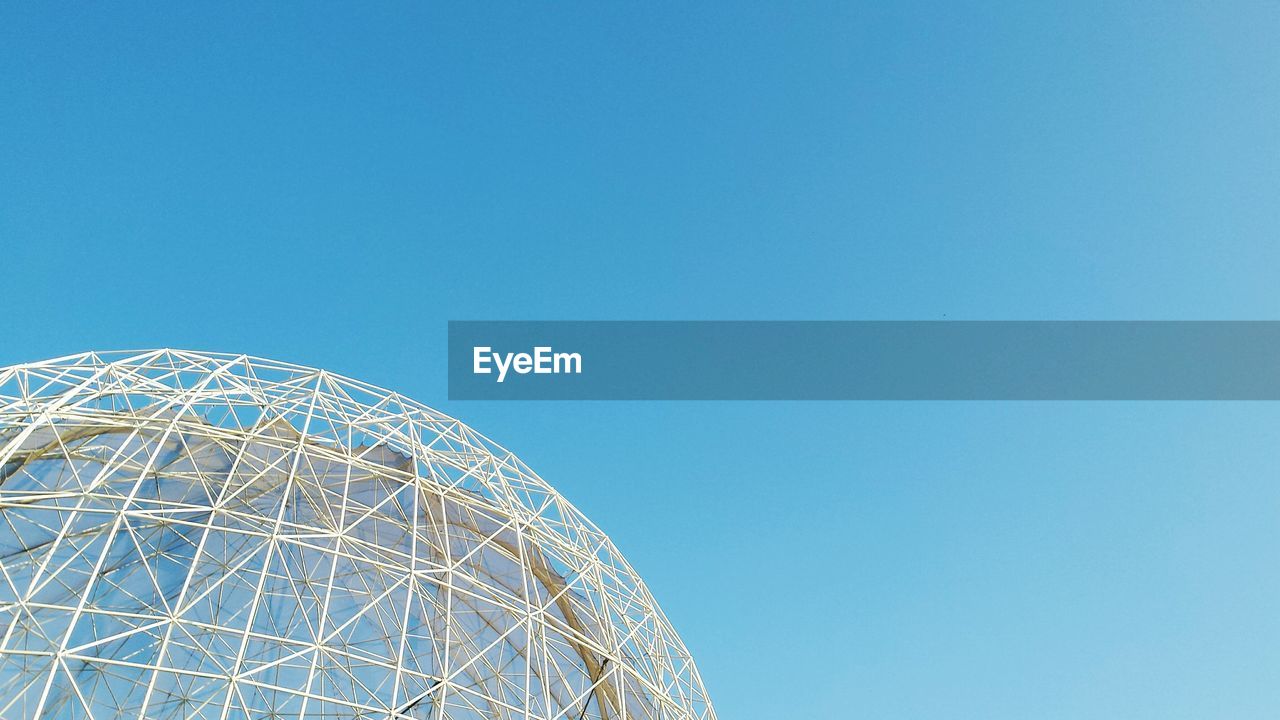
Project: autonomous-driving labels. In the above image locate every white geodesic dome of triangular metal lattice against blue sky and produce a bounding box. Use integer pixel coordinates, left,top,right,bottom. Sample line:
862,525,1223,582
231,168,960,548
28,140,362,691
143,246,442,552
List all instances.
0,350,714,720
